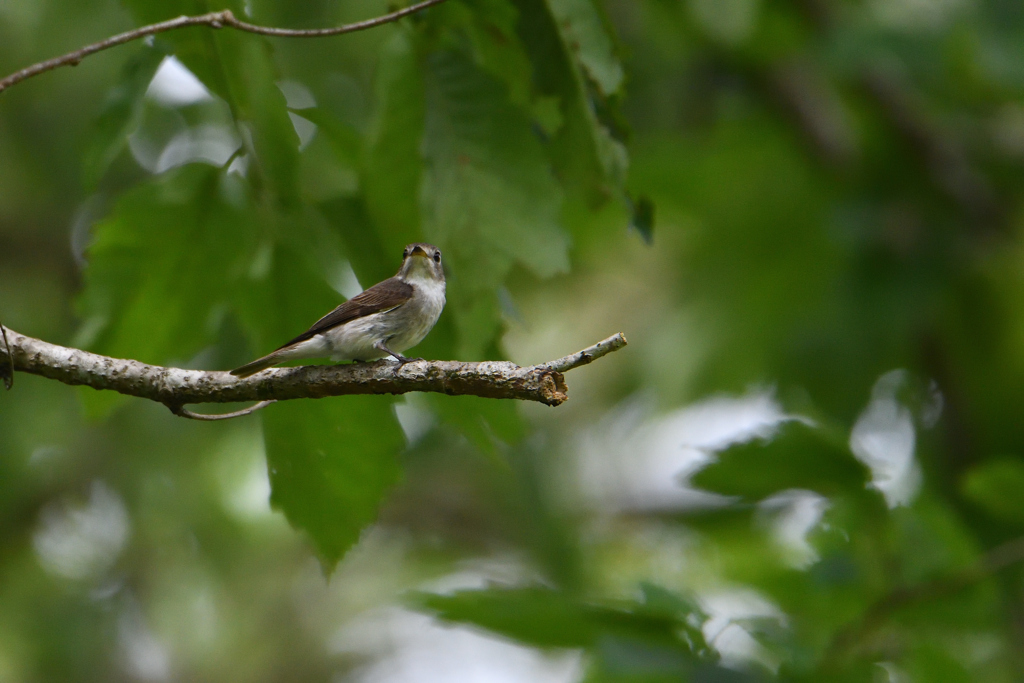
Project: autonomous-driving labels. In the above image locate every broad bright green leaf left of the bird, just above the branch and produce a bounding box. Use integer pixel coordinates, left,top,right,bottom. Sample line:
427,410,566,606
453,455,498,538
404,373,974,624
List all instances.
78,164,254,412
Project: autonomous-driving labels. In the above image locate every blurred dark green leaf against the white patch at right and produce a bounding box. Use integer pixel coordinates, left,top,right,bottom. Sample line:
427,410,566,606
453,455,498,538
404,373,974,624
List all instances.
691,421,870,500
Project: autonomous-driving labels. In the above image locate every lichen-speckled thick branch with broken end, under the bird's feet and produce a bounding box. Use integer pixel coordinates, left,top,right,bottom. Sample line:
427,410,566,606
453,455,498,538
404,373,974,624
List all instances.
0,329,626,413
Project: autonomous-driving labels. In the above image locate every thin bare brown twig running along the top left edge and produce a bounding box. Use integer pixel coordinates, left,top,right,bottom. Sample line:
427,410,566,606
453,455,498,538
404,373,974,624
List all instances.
0,0,444,92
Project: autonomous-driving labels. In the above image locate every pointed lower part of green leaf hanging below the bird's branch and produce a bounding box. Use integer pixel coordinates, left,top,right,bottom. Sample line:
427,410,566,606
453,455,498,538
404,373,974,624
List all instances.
263,396,404,570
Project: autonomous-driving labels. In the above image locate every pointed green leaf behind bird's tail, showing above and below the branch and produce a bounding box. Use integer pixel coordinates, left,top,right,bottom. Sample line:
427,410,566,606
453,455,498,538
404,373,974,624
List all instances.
237,246,404,569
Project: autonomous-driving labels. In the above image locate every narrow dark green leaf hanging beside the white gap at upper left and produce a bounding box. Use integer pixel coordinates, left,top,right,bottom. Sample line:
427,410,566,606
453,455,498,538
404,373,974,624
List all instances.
82,46,166,188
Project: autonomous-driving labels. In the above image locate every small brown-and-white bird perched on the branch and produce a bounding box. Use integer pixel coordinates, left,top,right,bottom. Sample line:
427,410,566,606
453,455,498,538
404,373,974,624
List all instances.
231,242,444,377
